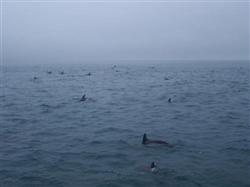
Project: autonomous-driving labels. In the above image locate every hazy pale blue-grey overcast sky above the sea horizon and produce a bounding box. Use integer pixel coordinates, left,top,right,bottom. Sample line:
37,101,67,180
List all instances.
2,1,249,64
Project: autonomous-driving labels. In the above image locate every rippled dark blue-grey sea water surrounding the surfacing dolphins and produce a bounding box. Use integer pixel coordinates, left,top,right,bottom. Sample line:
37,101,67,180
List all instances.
0,62,250,187
